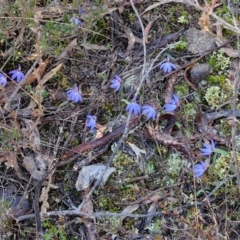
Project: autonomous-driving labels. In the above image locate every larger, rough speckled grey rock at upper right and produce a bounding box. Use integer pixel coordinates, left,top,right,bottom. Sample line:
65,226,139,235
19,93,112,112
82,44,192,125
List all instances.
185,28,217,55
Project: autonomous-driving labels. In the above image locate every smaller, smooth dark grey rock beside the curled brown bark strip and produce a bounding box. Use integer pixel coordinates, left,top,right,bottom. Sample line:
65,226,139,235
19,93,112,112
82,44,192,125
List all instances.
190,63,212,82
